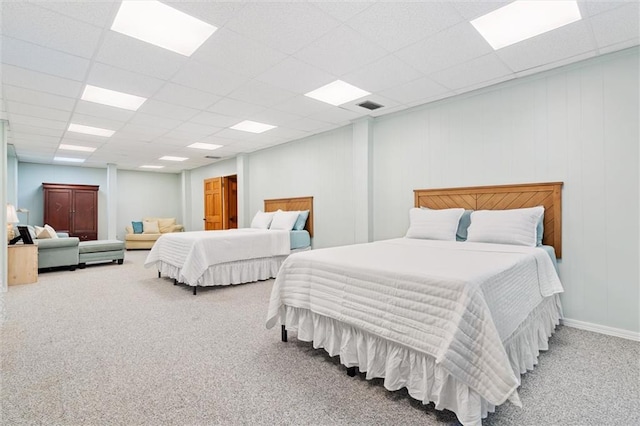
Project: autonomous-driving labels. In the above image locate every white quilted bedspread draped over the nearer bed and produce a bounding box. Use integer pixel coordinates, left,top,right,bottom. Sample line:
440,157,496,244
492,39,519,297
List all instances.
267,238,563,405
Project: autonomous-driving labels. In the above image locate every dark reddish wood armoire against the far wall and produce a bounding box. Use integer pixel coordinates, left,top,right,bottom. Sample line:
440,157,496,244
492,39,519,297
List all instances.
42,183,99,241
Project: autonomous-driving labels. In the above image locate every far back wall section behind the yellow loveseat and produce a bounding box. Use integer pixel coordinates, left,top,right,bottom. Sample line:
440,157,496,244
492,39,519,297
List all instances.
117,170,184,240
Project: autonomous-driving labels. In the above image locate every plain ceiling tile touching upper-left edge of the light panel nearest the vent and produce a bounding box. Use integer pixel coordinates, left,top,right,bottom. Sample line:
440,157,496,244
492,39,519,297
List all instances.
256,57,337,94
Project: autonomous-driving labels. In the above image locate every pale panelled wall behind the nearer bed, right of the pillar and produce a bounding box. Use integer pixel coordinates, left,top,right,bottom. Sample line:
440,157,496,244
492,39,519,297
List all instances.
373,49,640,332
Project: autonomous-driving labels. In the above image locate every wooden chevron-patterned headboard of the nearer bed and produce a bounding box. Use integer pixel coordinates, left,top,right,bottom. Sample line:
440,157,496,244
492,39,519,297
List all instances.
413,182,562,259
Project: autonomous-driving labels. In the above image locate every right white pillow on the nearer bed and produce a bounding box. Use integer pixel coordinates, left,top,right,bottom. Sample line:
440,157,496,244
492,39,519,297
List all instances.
467,206,544,247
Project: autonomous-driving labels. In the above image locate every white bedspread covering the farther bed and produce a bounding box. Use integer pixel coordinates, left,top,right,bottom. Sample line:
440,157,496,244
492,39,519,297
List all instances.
144,228,290,286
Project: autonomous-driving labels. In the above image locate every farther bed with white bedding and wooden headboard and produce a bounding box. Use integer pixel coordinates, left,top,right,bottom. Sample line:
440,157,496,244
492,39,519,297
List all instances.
145,197,313,294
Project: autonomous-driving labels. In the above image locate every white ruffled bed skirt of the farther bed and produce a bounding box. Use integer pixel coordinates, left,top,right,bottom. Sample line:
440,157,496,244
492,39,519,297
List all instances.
156,247,310,287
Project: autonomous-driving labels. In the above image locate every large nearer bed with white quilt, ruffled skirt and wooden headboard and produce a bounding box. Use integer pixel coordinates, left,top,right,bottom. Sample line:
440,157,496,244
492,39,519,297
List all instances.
267,183,563,425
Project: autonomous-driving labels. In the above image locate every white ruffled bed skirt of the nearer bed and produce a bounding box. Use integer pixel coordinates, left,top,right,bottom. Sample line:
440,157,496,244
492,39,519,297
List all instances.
280,295,562,426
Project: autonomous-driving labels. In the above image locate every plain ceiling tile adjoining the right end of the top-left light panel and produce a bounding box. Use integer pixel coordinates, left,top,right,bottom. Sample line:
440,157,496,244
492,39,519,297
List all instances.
191,28,287,77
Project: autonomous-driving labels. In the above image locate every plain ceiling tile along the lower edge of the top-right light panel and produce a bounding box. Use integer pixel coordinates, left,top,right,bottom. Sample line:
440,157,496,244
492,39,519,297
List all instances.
496,21,596,73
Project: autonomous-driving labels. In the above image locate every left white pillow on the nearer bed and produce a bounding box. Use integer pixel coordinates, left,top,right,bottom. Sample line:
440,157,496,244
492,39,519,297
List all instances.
405,208,464,241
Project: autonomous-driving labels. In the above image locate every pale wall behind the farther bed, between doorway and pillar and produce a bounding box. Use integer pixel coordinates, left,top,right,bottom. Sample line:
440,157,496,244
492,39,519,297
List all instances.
248,126,356,248
